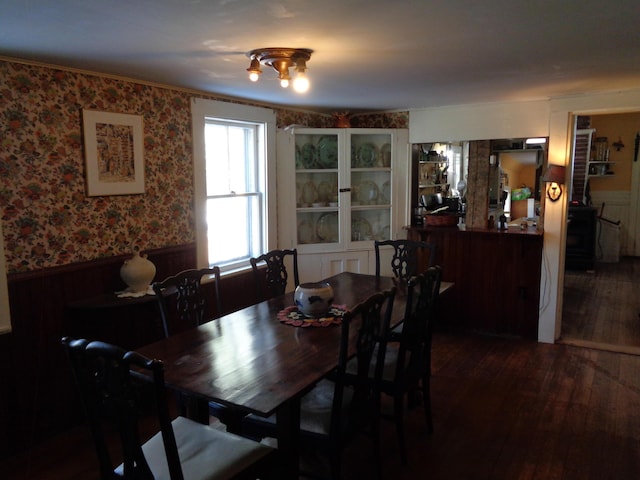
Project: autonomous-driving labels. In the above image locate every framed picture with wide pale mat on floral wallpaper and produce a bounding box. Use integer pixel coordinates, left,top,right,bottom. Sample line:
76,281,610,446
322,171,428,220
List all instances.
82,110,144,197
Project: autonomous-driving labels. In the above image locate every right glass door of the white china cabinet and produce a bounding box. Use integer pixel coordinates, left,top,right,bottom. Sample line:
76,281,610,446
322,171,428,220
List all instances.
348,133,392,242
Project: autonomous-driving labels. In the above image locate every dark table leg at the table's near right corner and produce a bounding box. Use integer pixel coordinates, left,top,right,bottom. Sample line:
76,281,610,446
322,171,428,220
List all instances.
276,398,300,480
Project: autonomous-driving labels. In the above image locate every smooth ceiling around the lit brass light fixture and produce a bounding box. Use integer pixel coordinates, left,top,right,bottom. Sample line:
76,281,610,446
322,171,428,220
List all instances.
0,0,640,113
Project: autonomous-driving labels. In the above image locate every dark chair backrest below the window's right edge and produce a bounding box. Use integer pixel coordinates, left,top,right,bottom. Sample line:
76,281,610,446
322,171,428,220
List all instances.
250,248,300,301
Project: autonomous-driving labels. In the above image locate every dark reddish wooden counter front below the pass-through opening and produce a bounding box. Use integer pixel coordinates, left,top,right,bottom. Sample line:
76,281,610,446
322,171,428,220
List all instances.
407,227,543,340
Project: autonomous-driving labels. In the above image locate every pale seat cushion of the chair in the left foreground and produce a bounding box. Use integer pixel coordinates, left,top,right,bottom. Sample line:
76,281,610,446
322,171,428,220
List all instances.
116,417,273,480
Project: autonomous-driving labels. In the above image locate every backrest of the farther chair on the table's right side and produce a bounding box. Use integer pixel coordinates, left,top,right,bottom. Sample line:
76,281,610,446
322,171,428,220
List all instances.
394,265,442,383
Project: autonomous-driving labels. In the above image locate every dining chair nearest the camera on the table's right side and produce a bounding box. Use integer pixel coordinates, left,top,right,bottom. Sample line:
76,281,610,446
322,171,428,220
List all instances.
242,287,396,480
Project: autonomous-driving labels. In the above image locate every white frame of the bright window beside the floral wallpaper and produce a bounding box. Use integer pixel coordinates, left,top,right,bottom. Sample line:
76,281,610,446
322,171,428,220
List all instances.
191,98,277,272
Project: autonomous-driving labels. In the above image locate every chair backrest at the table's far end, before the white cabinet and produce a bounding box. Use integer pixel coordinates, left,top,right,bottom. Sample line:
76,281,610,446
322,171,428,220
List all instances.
374,239,436,281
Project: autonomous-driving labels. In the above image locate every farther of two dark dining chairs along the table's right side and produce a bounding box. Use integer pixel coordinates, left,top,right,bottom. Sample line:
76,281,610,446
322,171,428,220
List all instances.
379,265,442,464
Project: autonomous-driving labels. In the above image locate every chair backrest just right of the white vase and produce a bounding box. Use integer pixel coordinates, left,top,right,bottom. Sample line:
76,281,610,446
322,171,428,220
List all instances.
152,267,222,337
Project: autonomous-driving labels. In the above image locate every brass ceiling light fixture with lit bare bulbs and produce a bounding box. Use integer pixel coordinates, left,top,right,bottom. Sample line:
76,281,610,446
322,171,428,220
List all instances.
247,48,313,93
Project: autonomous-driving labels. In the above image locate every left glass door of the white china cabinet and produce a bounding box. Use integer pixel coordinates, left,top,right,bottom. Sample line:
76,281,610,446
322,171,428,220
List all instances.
295,132,343,245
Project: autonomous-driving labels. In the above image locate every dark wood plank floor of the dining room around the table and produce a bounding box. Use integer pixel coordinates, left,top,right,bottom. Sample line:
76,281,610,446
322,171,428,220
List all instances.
5,333,640,480
